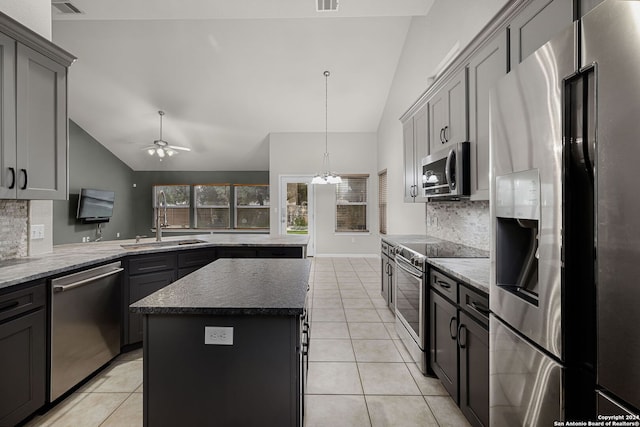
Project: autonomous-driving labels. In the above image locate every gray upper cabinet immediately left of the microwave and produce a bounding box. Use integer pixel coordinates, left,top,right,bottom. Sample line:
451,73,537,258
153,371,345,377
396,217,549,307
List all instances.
402,105,429,203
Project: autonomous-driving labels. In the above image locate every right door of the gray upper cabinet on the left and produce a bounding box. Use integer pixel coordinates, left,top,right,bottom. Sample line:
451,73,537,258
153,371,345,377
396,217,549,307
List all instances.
16,44,67,200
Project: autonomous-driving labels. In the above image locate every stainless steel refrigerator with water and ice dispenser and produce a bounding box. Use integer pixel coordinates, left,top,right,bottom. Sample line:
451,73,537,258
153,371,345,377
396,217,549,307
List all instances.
489,0,640,426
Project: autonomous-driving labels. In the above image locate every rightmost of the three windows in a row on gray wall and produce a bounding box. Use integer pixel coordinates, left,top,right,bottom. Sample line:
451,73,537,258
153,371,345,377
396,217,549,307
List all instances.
233,184,270,228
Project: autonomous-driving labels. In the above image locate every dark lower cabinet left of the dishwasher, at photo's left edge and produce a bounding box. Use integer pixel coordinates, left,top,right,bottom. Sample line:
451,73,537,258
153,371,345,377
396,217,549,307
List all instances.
0,282,47,426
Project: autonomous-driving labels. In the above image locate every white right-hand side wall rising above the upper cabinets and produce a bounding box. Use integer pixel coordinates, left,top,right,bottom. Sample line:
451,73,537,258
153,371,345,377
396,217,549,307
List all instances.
378,0,507,234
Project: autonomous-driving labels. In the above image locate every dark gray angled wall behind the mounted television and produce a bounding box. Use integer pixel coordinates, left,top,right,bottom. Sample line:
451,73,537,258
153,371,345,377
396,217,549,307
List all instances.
53,120,135,245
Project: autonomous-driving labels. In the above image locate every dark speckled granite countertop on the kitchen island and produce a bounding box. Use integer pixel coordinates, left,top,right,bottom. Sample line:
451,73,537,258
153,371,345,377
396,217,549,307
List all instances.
130,258,311,315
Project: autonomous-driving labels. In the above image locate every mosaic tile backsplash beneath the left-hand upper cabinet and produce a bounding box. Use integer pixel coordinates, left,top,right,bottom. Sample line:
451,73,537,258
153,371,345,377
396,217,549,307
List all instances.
0,200,29,260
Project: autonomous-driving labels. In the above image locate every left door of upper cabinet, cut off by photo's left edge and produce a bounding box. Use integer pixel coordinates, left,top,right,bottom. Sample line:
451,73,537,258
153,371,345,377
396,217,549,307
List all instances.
0,33,17,198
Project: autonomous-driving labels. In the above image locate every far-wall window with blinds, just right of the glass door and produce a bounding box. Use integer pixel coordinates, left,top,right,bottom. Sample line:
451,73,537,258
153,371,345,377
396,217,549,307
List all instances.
336,175,369,232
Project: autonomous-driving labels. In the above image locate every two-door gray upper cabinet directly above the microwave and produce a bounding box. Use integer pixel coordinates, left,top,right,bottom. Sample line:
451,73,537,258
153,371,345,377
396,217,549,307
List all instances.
429,68,467,153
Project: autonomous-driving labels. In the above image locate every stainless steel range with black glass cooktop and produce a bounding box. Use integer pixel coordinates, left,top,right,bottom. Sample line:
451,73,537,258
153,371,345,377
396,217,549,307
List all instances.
394,239,488,375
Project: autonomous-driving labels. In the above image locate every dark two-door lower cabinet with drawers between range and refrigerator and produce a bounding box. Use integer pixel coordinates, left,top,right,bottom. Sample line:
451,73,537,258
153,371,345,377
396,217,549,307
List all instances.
429,270,489,426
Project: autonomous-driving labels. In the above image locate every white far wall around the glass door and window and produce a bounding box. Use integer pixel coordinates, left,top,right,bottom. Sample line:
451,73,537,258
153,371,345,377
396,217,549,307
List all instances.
269,133,380,256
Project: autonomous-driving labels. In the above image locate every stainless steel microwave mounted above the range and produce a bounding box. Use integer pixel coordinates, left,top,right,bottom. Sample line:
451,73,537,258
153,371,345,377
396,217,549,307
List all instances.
422,141,471,198
